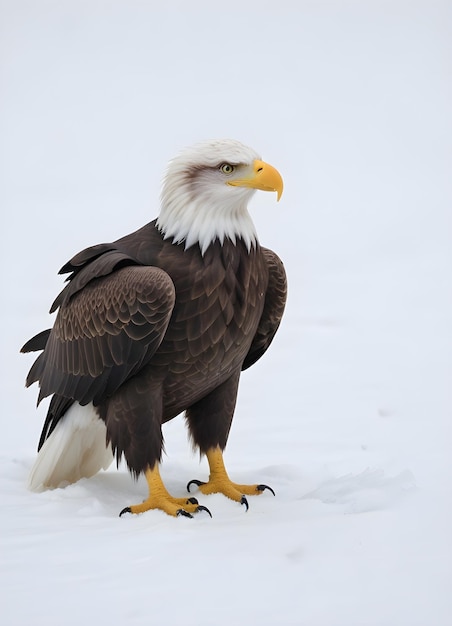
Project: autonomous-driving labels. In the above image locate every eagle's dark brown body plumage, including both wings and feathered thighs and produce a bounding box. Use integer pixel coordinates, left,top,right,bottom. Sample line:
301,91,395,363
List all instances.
23,222,286,474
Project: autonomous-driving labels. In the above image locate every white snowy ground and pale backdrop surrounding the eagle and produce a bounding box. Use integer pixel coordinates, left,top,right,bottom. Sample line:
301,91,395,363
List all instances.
0,0,452,626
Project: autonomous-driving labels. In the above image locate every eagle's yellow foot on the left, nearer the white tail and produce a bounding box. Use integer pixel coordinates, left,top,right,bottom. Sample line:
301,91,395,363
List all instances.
119,463,212,517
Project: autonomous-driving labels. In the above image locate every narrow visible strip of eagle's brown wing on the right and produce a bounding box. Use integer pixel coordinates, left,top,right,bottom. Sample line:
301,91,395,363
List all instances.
242,248,287,370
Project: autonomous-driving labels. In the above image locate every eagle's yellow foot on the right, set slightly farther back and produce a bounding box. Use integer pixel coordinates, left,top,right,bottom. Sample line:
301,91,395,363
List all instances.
187,448,275,510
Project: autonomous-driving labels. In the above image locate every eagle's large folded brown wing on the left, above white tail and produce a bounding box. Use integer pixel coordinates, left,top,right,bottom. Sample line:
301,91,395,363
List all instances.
24,266,175,404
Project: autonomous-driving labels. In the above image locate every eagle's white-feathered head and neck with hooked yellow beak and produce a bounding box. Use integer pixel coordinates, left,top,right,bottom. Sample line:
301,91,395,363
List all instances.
157,139,283,254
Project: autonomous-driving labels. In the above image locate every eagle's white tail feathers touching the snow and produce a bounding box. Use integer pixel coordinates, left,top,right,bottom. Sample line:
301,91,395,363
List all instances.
28,402,113,491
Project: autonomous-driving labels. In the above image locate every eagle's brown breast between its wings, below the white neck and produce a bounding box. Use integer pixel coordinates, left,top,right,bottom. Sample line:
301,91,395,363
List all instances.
150,240,268,413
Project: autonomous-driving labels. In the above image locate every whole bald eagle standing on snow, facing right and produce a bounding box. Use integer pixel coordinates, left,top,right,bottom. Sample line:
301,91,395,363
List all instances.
21,140,287,517
